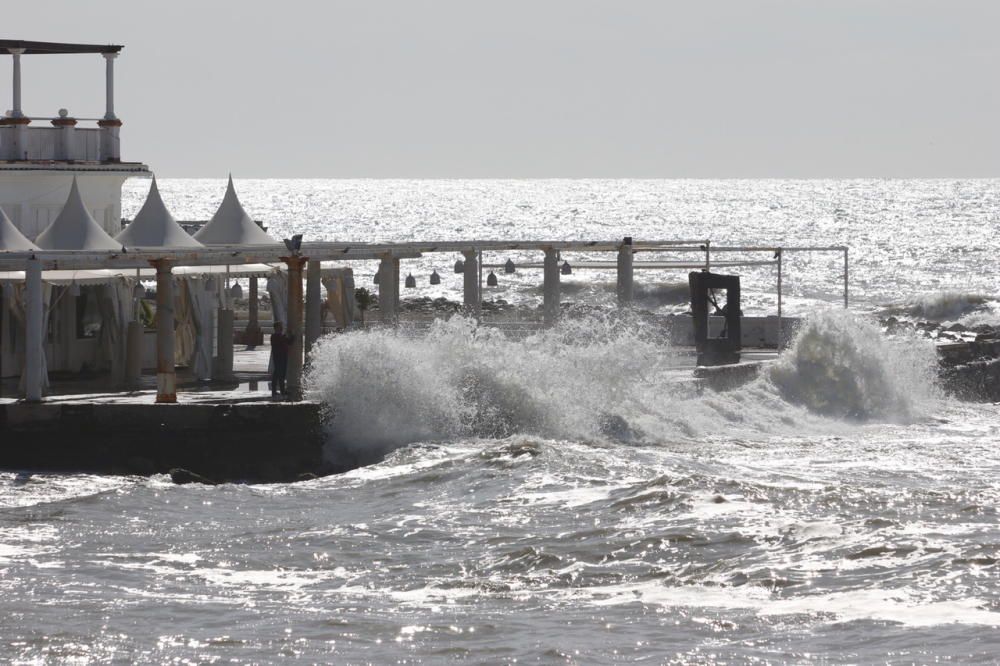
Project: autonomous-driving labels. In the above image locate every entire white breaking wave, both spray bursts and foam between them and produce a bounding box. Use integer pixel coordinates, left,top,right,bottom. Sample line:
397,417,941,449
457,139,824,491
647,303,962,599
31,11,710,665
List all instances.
306,311,934,456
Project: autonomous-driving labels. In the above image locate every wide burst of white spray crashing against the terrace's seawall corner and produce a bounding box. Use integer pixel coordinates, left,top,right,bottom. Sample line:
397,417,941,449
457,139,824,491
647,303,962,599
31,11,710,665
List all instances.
306,317,677,451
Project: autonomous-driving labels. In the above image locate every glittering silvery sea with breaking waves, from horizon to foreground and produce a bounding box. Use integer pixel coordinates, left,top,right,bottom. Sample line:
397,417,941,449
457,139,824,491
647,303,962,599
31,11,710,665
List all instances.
0,178,1000,664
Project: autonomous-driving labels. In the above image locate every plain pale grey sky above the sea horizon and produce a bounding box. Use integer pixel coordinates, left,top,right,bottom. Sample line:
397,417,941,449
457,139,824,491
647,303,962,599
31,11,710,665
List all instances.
0,0,1000,178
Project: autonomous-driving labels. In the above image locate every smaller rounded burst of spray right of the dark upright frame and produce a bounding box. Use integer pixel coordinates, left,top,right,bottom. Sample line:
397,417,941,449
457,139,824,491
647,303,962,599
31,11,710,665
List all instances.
769,310,936,420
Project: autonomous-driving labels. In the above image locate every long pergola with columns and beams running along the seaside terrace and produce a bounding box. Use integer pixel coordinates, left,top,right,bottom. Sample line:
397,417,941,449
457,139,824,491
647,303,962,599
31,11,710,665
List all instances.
0,238,847,403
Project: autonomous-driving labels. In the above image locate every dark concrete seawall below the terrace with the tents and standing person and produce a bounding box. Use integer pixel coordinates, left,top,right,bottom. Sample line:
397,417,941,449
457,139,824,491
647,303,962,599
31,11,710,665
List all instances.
0,402,332,482
